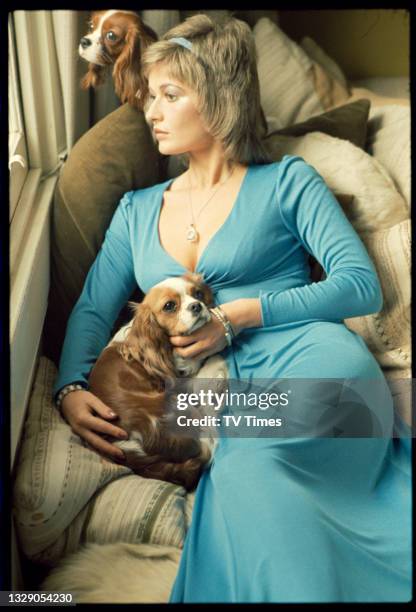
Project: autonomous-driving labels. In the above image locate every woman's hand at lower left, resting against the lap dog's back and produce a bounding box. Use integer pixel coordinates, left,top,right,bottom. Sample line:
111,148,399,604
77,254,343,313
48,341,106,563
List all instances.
61,390,128,461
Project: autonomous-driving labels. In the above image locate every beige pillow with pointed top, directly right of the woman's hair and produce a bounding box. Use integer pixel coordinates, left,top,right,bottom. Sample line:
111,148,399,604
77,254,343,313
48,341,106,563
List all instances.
253,17,325,129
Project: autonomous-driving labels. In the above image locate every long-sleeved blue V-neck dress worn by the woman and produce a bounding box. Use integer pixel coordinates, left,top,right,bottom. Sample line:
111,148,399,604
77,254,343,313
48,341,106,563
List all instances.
54,156,412,603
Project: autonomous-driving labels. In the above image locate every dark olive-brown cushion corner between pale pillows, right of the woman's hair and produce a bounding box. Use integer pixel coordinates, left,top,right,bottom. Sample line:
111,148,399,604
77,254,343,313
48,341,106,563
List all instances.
266,99,370,149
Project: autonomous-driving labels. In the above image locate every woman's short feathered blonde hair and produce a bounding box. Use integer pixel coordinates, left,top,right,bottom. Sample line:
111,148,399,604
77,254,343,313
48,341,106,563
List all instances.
141,14,271,165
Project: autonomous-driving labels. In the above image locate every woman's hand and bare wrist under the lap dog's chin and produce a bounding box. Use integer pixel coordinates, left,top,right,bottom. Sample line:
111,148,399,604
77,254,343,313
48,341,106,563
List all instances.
170,298,261,359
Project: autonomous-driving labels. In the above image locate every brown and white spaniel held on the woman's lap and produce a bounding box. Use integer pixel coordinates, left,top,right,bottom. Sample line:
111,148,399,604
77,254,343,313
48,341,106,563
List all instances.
88,273,221,490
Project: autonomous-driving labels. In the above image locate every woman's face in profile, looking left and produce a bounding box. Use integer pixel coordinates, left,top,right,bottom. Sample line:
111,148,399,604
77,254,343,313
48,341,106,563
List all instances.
146,63,214,155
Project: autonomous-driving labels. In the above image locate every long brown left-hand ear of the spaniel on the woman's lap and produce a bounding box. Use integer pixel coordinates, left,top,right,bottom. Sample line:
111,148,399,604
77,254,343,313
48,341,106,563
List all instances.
120,302,176,379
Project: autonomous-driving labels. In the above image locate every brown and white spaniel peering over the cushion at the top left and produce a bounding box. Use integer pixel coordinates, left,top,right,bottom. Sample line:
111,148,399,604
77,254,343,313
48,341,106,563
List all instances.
78,9,157,109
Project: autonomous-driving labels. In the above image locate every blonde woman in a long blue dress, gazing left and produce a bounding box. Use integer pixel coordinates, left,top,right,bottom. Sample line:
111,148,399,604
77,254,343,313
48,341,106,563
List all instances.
55,15,411,602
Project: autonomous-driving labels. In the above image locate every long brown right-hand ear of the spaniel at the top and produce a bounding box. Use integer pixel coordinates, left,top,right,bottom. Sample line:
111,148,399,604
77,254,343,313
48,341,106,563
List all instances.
113,21,157,109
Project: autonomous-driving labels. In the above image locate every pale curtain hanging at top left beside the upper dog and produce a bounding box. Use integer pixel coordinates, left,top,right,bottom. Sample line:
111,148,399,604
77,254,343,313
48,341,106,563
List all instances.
12,10,120,174
